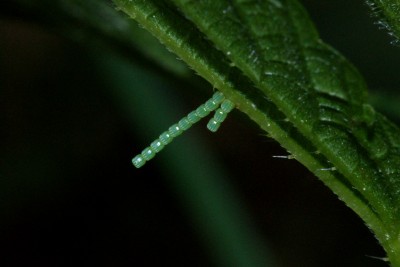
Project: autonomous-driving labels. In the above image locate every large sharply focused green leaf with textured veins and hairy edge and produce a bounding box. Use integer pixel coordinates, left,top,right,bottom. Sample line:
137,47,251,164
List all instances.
114,0,400,266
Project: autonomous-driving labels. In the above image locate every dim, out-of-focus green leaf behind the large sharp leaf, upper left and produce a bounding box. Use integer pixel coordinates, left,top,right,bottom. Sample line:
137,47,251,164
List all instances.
2,0,190,78
